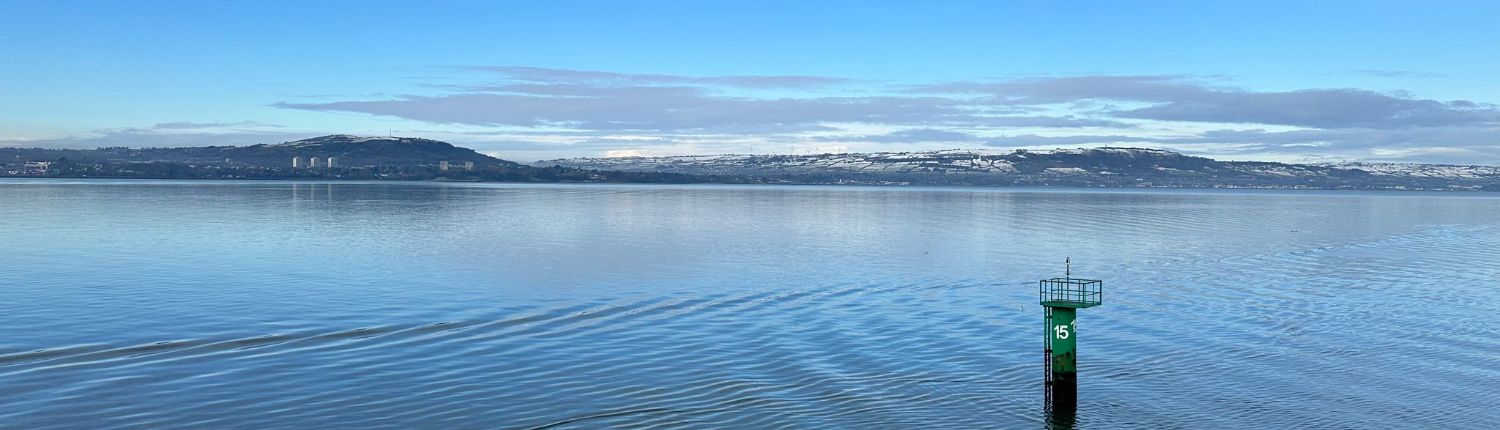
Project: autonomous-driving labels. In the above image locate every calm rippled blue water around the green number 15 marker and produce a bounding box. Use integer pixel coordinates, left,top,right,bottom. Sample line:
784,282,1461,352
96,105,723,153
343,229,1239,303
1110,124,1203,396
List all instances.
0,181,1500,429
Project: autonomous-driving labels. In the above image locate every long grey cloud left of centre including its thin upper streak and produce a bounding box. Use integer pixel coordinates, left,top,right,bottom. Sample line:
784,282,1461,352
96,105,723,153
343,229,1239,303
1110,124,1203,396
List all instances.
272,66,1130,135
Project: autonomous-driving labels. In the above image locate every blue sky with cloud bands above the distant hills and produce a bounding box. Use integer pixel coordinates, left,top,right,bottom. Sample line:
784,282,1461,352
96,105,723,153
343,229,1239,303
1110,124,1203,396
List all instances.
0,0,1500,165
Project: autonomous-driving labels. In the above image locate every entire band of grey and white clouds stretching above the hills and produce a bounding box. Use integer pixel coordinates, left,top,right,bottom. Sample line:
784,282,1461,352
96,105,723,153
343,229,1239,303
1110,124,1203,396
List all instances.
20,66,1500,163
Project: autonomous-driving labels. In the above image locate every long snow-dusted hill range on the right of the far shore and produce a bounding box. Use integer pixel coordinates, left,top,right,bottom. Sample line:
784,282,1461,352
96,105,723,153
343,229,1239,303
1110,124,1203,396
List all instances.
534,148,1500,190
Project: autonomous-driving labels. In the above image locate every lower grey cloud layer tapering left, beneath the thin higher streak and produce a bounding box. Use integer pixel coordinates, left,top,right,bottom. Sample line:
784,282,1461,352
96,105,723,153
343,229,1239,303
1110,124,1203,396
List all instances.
273,94,1125,133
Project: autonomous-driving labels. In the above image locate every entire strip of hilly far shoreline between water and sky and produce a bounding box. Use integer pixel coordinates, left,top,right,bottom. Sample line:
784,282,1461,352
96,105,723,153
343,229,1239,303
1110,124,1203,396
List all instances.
0,135,1500,192
